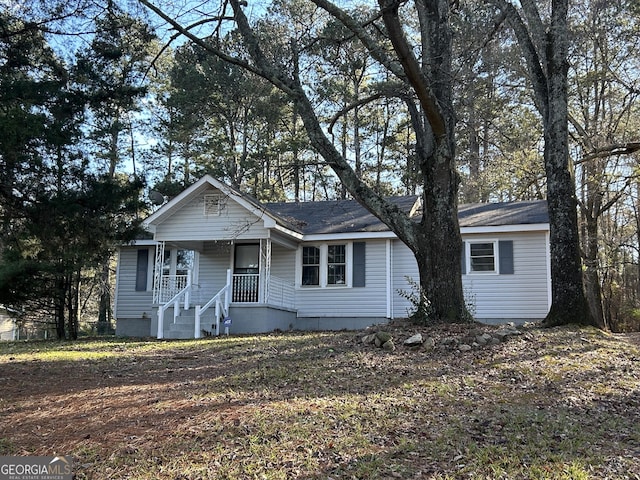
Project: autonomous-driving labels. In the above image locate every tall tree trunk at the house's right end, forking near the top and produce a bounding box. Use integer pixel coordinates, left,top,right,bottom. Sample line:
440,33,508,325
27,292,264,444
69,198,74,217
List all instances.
496,0,595,326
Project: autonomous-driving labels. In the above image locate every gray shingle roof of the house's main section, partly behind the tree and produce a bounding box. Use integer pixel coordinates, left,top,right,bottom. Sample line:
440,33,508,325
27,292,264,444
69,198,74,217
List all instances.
265,195,549,235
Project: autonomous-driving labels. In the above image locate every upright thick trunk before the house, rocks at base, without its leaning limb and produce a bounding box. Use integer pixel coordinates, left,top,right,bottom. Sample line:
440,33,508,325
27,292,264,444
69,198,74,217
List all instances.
378,0,471,323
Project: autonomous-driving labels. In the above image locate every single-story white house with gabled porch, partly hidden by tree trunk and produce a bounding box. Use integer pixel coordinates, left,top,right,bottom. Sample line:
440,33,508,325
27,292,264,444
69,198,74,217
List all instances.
115,176,551,338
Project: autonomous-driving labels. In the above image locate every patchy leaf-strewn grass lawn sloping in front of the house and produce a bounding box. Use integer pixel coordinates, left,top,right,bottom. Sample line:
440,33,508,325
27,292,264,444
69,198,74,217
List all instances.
0,328,640,480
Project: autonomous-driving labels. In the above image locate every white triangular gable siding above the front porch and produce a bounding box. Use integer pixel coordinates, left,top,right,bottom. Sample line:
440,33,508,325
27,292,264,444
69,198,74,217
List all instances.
155,189,268,241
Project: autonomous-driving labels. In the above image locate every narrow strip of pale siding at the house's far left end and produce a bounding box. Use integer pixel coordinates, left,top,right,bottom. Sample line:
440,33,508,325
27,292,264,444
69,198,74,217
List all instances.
115,247,155,318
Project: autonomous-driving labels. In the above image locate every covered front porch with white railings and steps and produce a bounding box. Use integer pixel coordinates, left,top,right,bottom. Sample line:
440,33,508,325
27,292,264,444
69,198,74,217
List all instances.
153,238,295,338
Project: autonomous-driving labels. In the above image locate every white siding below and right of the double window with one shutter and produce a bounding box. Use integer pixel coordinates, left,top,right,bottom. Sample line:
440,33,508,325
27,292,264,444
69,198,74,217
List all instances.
296,240,387,318
